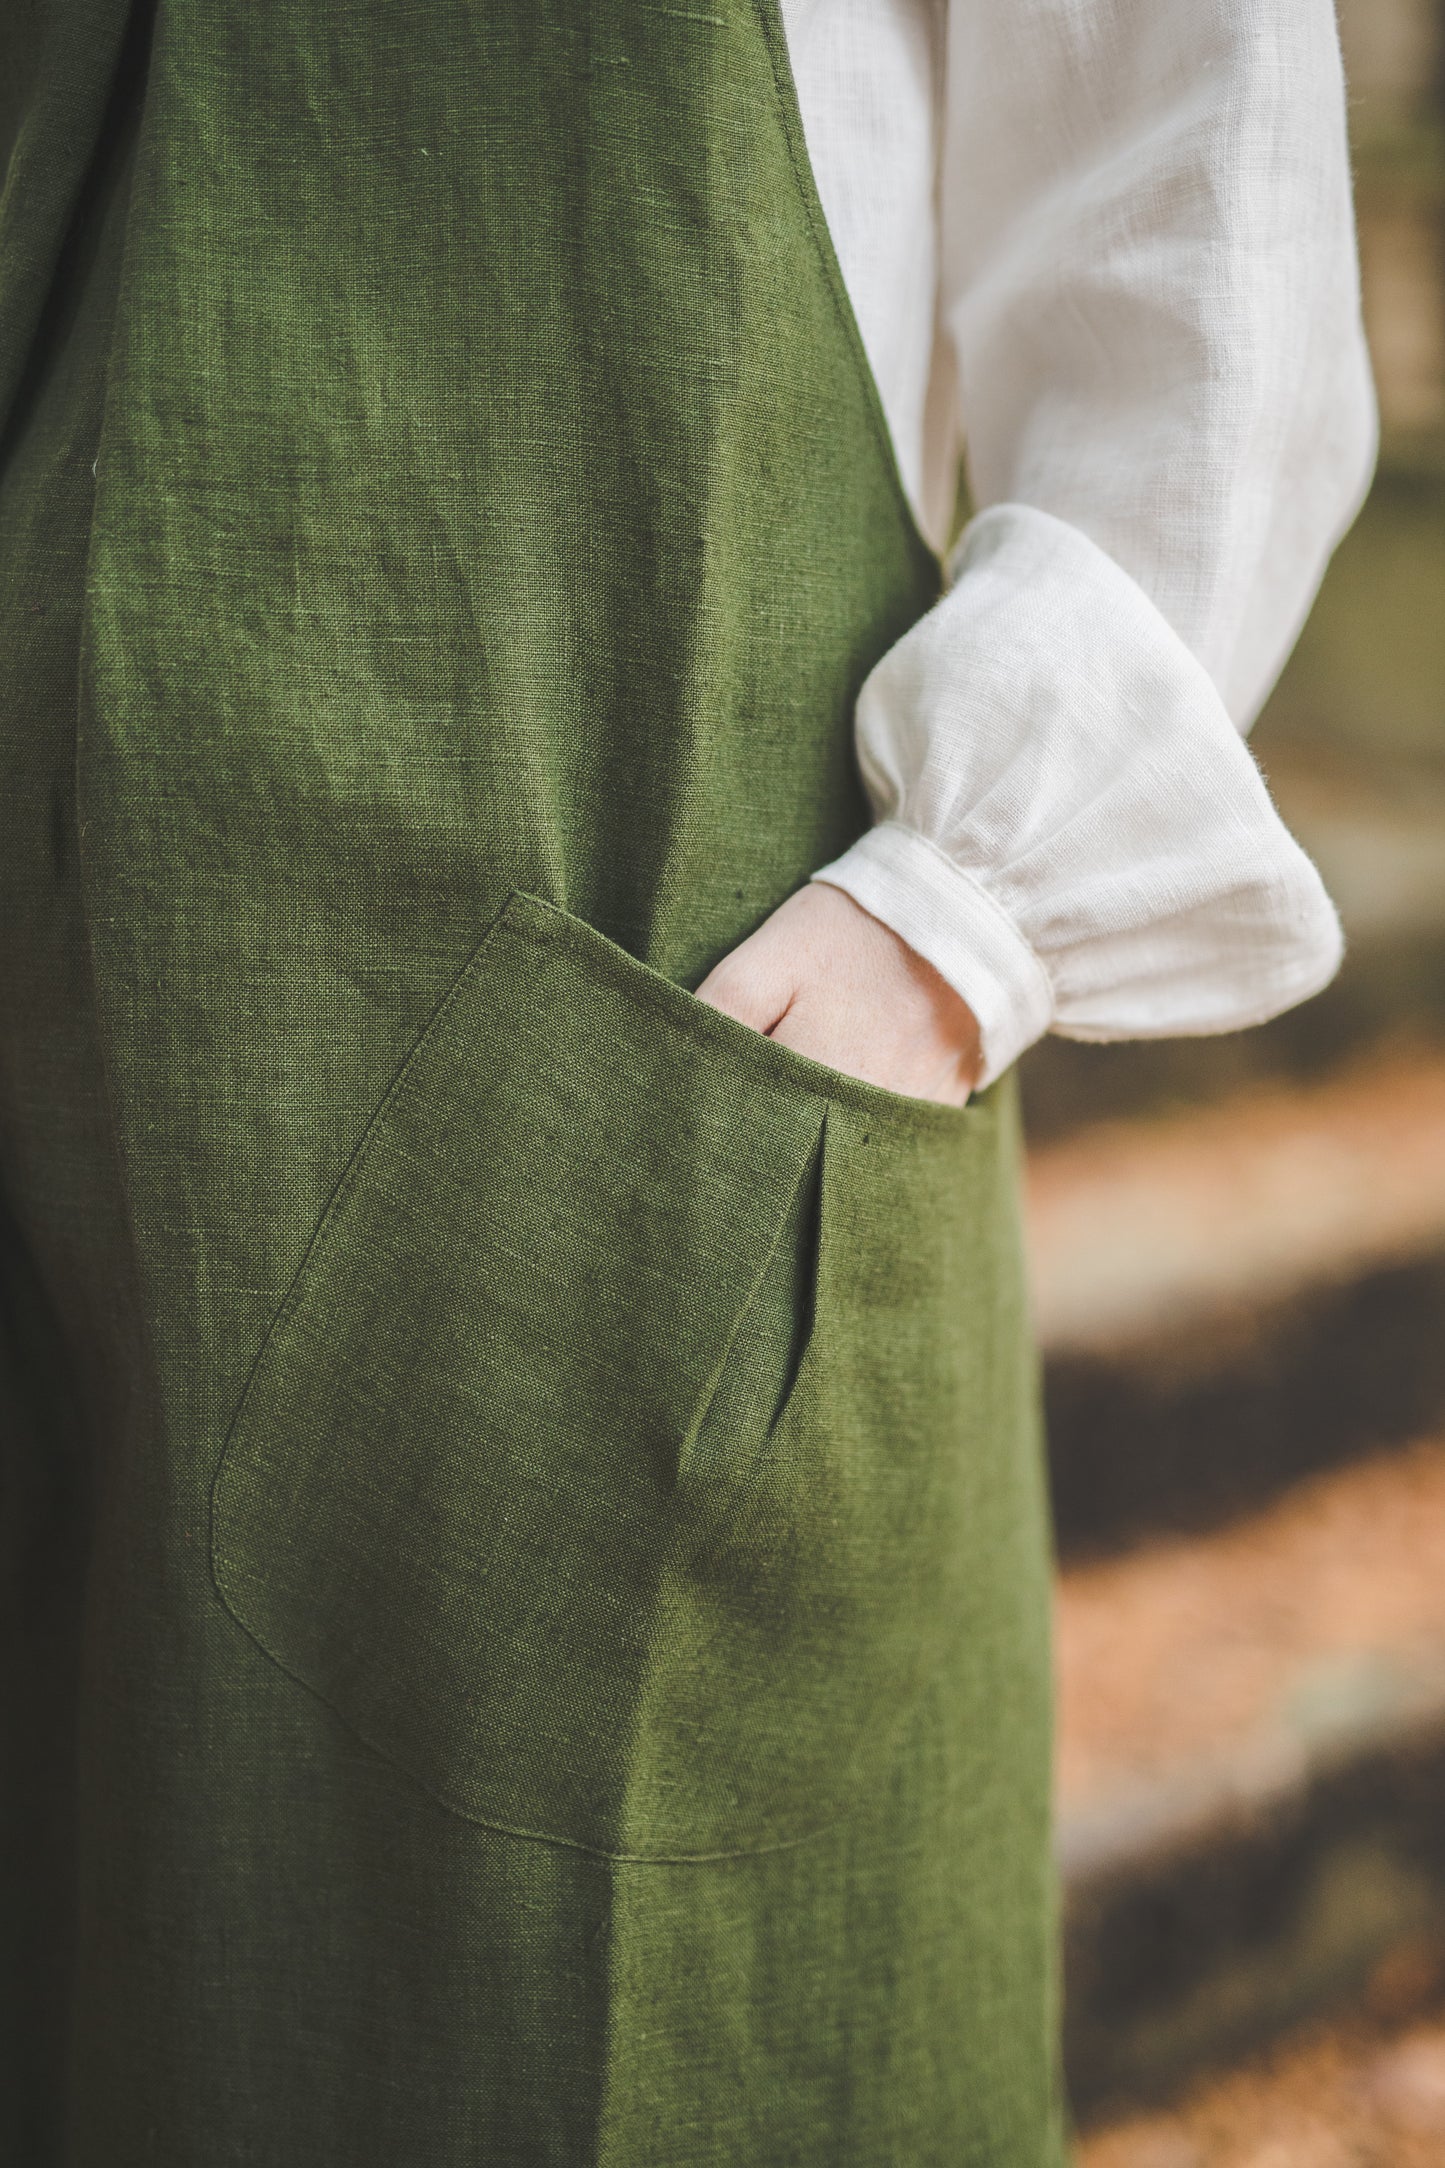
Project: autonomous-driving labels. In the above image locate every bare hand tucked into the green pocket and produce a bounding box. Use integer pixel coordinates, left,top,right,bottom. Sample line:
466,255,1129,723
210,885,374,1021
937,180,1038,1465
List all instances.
698,880,984,1106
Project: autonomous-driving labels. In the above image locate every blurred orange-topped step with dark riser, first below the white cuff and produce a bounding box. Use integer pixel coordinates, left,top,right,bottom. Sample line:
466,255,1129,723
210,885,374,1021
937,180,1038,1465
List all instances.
1029,1051,1445,1557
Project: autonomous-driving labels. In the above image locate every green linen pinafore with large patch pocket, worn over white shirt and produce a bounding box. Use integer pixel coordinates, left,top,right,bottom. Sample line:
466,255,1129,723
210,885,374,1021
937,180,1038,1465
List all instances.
0,0,1059,2168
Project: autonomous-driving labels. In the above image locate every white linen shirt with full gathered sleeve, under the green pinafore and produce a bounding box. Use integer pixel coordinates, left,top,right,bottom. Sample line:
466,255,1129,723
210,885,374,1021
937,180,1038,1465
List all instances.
782,0,1376,1084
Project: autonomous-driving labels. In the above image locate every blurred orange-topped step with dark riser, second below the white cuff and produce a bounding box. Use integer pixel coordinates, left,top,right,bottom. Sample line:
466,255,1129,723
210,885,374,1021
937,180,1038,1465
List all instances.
1057,1437,1445,2115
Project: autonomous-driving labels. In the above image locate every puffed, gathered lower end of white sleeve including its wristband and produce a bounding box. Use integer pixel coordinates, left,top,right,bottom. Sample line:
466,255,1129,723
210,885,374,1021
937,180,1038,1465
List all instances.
817,505,1341,1080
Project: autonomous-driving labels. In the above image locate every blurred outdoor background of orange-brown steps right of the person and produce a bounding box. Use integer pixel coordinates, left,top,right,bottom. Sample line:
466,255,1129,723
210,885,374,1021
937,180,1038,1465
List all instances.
1025,0,1445,2168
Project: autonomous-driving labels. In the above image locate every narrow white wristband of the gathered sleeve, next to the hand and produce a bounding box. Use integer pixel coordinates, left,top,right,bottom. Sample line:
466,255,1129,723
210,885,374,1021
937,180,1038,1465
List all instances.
812,820,1055,1088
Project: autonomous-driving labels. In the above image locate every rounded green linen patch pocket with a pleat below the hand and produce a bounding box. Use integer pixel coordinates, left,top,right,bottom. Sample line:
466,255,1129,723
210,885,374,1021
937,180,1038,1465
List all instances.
212,895,992,1860
